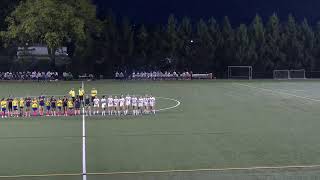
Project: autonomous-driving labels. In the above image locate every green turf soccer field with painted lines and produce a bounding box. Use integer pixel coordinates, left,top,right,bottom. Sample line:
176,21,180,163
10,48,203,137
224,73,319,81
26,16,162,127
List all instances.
0,80,320,180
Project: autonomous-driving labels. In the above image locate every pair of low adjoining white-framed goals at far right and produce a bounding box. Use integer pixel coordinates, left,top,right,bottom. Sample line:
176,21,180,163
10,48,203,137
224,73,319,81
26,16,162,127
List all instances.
273,69,306,80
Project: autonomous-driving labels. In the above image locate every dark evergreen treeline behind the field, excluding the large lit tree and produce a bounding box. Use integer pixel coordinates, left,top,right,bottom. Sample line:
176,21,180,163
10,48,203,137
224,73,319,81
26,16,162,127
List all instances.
0,0,320,77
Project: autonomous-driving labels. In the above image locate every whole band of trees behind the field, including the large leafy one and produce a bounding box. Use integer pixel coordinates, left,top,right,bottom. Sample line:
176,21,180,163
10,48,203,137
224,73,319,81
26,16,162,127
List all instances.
0,0,320,77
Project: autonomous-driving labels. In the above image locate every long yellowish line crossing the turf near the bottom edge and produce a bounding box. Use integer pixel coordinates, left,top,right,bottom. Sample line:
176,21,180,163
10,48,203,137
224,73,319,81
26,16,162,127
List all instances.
0,165,320,178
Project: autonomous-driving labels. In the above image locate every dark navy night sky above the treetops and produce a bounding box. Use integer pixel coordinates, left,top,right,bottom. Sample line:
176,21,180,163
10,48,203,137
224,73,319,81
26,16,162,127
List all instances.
94,0,320,24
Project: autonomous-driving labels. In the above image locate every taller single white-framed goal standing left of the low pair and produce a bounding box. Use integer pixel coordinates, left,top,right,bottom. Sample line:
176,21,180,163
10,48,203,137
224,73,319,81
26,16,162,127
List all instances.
228,66,252,80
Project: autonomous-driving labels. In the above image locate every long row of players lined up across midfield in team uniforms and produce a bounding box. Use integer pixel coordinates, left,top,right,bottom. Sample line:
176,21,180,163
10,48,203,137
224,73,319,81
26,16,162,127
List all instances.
0,95,156,118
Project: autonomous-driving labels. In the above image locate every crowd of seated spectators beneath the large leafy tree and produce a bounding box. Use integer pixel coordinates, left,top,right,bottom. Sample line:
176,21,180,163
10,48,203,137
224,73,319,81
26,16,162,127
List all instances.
0,71,59,81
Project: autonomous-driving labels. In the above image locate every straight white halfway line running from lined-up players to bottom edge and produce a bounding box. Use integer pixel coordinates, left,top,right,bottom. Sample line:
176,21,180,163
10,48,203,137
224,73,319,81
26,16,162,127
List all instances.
82,81,87,180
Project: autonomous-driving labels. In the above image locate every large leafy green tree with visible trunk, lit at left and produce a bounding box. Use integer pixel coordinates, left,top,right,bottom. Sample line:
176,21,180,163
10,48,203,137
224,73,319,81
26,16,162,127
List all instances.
2,0,94,68
